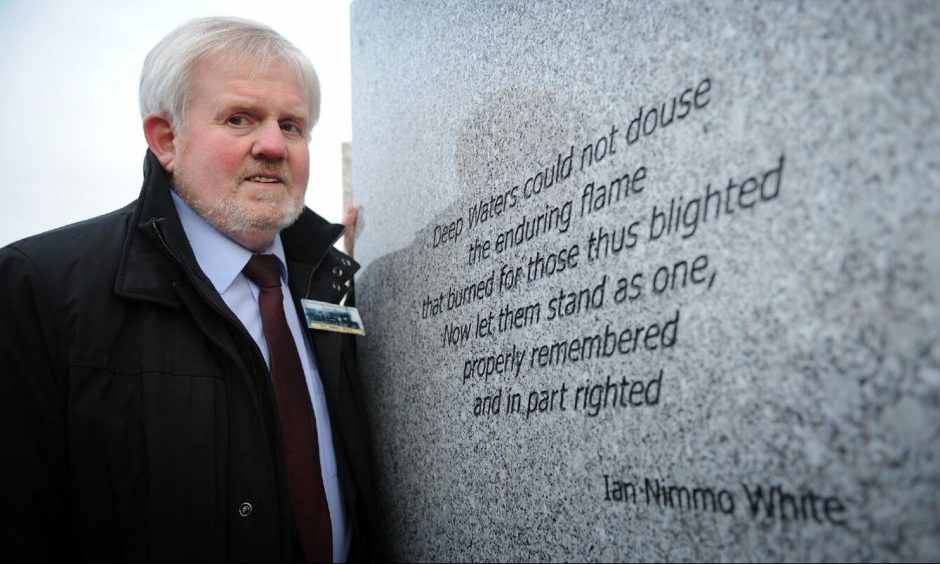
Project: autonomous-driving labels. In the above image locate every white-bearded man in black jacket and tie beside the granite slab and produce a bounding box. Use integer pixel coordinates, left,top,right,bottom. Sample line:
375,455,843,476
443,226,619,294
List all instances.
0,18,377,562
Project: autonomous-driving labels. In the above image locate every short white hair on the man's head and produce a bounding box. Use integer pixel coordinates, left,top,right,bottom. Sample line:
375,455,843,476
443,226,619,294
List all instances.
140,17,320,132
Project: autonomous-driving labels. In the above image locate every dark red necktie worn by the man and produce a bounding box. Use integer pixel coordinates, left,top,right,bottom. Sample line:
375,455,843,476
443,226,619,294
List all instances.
244,255,333,562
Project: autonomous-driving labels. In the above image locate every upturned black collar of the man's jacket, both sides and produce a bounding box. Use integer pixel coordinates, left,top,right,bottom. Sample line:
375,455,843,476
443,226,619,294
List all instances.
114,150,359,306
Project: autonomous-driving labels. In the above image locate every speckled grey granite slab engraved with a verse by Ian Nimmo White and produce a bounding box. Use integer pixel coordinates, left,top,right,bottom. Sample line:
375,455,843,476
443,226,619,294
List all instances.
352,0,940,561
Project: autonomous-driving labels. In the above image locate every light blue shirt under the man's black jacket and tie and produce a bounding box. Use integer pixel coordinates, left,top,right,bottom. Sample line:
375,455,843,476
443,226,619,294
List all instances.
172,192,351,562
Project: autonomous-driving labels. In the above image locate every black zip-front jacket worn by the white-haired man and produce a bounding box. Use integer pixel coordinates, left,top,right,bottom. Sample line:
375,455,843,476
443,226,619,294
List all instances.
0,151,377,562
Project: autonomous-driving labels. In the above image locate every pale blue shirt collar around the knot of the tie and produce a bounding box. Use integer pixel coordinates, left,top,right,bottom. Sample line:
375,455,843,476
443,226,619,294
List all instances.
171,190,287,294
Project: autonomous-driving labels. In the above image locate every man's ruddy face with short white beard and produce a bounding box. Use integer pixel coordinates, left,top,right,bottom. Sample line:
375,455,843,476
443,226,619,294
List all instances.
167,57,310,248
